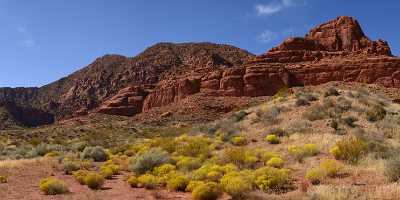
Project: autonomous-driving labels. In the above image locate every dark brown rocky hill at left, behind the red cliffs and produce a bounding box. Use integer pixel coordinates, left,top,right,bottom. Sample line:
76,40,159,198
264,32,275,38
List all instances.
0,43,253,126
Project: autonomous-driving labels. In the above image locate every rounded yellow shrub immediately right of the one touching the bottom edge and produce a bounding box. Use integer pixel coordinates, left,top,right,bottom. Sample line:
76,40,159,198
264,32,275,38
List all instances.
221,172,253,199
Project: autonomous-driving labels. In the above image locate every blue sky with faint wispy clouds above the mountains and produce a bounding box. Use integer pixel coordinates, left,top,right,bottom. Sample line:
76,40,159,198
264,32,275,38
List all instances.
0,0,400,87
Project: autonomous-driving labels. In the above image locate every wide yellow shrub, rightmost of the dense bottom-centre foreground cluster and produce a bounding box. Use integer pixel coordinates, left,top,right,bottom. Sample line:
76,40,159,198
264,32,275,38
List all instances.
255,167,290,191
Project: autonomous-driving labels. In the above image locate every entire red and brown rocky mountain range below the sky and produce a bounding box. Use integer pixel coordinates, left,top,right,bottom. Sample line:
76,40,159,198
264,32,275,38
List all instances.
0,16,400,128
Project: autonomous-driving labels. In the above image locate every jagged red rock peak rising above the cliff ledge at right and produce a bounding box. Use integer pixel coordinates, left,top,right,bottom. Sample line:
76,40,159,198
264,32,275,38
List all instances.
255,17,391,63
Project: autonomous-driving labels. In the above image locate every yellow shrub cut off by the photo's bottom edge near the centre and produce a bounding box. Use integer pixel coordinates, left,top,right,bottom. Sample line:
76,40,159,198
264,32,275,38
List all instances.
192,182,222,200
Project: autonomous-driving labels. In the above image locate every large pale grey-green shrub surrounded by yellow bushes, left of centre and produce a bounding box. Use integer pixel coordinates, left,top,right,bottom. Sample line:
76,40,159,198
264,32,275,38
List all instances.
131,148,170,174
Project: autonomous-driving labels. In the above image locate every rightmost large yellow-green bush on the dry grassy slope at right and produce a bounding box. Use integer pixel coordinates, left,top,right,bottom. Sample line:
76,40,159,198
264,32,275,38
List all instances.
330,137,368,163
